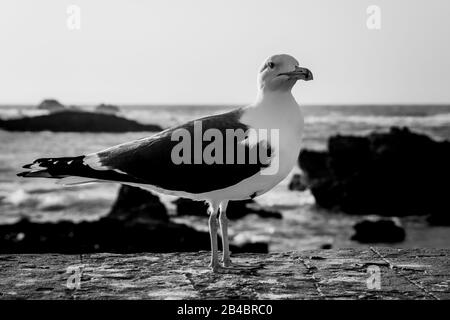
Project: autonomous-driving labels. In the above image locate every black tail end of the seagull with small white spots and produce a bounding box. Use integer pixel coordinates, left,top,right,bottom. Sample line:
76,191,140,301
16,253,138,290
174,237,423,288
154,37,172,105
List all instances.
17,156,98,185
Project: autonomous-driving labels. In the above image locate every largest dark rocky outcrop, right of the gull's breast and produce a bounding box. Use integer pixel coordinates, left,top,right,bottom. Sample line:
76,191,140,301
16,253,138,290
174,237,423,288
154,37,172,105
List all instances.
299,128,450,216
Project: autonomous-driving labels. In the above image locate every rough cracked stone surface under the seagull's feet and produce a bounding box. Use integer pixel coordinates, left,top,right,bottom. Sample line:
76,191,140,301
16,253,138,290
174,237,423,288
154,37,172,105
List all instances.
0,248,450,299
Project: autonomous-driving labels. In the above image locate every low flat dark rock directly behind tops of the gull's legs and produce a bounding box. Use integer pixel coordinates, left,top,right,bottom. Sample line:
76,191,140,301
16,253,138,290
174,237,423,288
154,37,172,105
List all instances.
174,198,282,220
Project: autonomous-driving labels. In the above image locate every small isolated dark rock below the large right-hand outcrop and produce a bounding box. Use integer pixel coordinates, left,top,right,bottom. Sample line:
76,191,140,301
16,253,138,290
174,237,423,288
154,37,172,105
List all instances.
351,218,406,243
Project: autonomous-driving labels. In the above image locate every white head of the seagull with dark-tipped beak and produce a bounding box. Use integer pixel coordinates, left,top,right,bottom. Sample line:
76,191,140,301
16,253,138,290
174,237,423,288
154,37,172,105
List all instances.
258,54,313,91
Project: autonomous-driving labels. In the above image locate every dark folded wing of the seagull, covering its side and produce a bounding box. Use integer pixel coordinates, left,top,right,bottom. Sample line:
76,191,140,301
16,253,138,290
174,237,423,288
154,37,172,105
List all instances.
83,109,271,193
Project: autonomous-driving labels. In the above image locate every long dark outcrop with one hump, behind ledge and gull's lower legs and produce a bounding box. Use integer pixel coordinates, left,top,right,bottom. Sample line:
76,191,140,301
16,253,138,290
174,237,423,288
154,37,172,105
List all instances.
0,186,268,254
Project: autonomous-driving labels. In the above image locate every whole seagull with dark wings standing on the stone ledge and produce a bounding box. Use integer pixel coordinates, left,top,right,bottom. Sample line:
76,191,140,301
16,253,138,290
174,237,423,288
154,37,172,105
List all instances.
18,54,313,272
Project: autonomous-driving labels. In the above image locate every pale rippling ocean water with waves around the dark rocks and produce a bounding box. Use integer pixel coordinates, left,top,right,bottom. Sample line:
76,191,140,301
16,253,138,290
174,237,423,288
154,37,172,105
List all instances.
0,105,450,252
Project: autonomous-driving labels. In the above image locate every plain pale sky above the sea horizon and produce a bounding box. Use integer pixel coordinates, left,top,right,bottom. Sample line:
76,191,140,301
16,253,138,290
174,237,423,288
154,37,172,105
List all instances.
0,0,450,104
